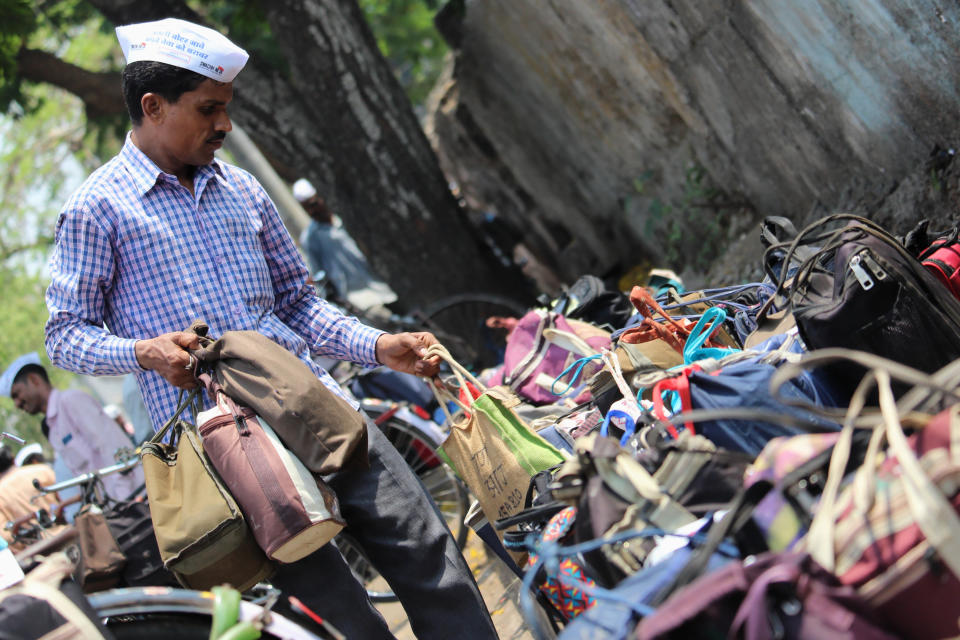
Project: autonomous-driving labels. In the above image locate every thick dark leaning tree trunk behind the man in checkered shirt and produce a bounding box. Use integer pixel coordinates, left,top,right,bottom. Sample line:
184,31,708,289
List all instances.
84,0,525,306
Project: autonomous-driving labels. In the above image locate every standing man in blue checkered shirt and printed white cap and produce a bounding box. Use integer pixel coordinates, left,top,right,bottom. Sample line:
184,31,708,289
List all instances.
46,20,496,639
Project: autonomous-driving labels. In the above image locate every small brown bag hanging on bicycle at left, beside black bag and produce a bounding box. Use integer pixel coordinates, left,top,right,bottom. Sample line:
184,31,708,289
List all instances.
73,504,127,593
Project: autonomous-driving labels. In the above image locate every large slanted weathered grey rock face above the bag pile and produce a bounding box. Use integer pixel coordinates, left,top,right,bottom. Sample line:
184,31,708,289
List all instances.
428,0,960,279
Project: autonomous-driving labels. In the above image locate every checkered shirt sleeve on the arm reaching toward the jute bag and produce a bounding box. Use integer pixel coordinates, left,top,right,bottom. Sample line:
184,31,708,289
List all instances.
261,185,384,366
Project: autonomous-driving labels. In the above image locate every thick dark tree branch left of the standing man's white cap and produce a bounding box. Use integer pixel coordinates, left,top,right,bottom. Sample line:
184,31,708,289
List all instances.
17,48,126,118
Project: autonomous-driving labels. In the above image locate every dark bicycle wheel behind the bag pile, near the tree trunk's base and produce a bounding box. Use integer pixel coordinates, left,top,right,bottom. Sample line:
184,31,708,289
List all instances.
423,293,527,371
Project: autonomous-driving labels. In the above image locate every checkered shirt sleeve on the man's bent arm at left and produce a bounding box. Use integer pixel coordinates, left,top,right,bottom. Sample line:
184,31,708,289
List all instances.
45,203,142,375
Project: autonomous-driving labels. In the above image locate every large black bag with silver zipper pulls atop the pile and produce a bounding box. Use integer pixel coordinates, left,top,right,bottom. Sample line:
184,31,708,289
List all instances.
778,214,960,392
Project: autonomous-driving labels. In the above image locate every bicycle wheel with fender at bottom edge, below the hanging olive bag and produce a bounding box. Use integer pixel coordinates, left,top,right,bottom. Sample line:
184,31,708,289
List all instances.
87,587,321,640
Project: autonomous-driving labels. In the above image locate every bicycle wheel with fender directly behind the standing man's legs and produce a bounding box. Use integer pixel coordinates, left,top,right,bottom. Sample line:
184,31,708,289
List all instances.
336,399,470,602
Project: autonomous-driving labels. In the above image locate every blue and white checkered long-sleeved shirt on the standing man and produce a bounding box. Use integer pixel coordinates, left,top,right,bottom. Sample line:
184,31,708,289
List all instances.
46,135,382,436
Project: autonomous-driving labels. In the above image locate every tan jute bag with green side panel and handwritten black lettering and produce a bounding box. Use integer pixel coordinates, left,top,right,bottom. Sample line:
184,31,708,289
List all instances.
427,344,565,556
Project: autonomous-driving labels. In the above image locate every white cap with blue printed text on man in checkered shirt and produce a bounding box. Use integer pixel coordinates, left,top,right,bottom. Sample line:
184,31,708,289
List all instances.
117,18,250,82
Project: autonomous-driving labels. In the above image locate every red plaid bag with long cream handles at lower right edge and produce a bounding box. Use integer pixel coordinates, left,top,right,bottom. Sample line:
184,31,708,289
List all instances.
785,349,960,638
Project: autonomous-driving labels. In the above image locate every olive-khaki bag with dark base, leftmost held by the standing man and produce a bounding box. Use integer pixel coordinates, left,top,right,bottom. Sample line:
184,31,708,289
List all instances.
140,391,273,591
